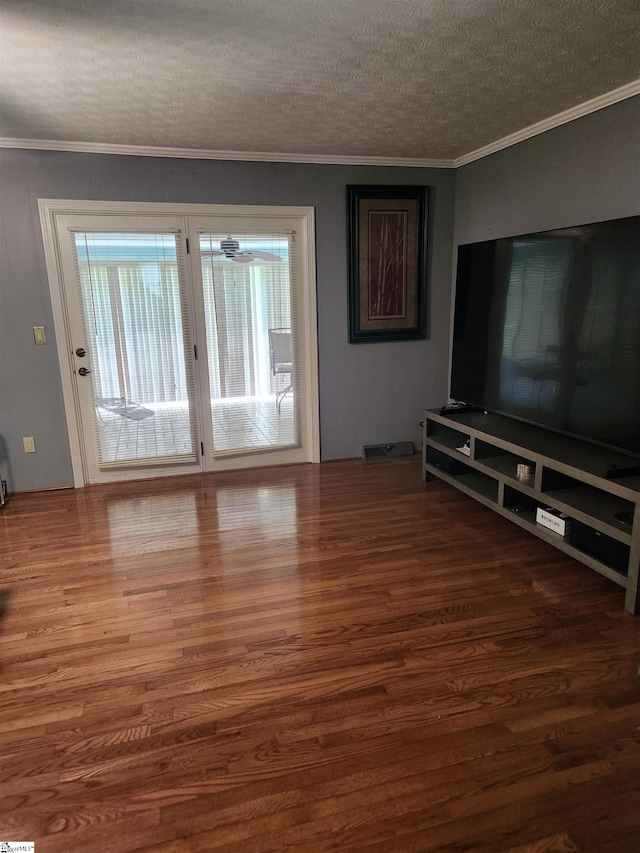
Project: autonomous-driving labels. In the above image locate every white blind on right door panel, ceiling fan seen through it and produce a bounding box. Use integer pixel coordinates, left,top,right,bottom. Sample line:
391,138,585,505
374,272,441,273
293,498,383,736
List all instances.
199,232,300,455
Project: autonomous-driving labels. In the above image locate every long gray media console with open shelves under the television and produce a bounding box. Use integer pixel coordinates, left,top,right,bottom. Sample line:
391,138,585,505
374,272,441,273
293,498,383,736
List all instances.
423,409,640,614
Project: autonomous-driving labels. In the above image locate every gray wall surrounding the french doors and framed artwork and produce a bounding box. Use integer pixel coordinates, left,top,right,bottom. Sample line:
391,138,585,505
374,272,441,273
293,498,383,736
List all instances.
0,149,455,491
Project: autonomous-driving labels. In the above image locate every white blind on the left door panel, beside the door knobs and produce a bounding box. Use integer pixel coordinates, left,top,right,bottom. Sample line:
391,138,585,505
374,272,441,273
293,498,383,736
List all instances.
71,231,197,468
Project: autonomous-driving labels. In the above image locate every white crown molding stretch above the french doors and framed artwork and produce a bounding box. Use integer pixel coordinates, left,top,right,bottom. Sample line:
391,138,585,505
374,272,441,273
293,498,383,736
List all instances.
0,137,455,169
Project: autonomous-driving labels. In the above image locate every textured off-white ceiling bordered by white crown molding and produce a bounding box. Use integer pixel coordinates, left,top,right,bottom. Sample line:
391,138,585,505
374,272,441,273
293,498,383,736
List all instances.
0,0,640,161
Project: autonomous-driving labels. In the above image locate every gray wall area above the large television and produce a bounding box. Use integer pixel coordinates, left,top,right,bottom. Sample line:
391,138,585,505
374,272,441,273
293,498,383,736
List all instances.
455,96,640,245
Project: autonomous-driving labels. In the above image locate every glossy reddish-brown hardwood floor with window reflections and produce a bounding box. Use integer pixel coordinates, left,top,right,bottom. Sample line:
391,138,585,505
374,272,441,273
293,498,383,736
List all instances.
0,458,640,853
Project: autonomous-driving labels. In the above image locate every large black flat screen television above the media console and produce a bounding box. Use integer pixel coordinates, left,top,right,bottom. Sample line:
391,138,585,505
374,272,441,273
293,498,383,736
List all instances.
450,216,640,456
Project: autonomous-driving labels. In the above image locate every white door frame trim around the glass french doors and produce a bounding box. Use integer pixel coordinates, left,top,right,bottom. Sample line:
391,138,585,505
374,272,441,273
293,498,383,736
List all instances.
38,199,320,488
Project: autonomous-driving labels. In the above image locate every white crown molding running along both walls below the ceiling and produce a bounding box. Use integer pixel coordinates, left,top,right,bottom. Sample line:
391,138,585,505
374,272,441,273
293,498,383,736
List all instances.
0,80,640,169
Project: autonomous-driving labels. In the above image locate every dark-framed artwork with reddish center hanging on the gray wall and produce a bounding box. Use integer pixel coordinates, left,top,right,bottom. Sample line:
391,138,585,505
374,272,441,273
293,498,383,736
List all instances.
347,186,428,344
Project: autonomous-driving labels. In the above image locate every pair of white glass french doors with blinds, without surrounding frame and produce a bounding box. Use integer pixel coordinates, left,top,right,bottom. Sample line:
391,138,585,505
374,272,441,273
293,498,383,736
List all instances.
50,209,316,482
